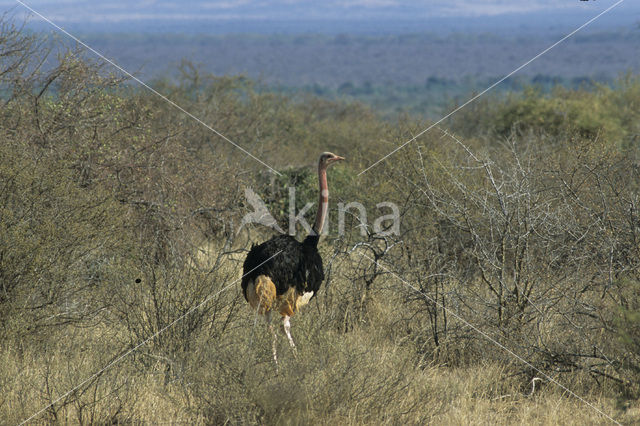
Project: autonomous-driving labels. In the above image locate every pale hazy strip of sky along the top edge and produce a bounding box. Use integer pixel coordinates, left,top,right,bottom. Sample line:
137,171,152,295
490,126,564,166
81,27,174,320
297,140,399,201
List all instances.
0,0,640,22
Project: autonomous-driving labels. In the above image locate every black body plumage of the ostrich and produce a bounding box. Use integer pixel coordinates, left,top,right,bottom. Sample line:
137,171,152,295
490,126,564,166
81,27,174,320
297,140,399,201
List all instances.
242,235,324,300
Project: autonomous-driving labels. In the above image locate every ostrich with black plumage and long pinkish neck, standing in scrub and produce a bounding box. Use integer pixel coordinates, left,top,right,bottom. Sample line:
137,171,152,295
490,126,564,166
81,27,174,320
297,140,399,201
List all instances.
242,152,344,364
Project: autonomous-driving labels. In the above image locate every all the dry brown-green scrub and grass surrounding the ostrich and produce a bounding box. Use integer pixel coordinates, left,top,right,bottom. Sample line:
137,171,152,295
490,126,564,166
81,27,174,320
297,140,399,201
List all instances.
0,15,640,424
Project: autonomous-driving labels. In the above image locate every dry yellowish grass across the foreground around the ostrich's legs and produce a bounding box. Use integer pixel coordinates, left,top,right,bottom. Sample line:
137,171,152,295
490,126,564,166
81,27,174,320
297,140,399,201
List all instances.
0,260,640,425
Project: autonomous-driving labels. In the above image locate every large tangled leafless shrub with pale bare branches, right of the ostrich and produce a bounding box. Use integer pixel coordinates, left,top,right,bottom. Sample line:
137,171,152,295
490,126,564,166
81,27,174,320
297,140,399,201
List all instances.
378,132,637,382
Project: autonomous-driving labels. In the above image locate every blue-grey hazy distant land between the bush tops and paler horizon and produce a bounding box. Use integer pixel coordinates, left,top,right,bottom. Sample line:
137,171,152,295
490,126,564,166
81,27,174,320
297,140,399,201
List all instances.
83,29,640,89
